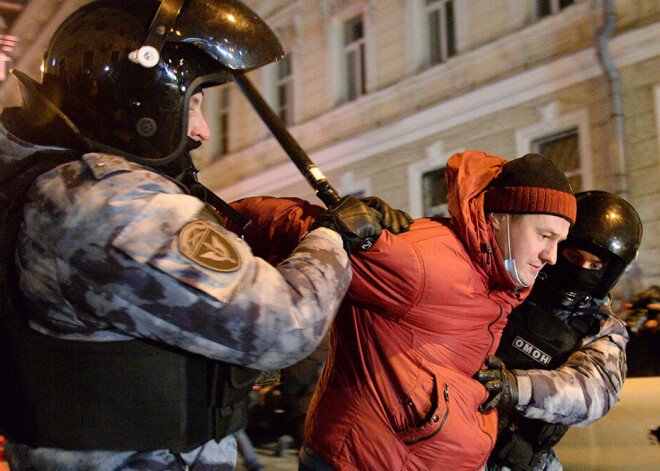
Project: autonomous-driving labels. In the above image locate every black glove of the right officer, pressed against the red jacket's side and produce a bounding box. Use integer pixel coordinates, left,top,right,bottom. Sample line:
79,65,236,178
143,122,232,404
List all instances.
474,355,518,412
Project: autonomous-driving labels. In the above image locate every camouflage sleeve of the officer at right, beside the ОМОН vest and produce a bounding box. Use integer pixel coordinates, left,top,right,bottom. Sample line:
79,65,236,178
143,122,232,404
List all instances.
514,314,628,427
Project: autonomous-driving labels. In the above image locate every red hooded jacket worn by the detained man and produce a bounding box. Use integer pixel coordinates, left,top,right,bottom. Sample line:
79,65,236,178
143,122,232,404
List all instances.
232,151,521,471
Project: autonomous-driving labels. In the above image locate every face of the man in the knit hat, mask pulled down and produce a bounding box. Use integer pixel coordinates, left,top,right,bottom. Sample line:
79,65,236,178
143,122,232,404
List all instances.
488,213,570,286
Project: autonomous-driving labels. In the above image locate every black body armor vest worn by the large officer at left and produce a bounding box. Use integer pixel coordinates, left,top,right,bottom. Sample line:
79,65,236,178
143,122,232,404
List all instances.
0,154,259,452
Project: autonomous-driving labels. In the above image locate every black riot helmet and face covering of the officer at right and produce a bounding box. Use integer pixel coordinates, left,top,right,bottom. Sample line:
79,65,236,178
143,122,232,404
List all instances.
539,191,642,307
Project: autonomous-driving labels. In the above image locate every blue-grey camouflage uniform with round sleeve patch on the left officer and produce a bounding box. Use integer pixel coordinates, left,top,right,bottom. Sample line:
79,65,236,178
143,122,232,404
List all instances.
0,123,351,471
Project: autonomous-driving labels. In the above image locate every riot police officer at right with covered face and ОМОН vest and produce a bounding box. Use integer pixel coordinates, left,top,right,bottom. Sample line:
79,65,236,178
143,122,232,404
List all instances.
477,191,642,471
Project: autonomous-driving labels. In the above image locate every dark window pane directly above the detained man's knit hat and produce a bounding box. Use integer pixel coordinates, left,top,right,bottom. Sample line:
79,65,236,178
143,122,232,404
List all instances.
532,128,584,192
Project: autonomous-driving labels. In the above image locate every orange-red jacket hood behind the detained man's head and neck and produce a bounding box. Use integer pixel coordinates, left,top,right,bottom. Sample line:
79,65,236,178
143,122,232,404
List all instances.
446,151,516,290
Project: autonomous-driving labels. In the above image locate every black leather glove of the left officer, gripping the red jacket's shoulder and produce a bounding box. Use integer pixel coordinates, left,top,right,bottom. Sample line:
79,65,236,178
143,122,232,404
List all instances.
311,195,382,254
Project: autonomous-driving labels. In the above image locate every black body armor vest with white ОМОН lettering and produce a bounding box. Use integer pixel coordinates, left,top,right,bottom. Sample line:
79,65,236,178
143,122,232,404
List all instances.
489,301,600,471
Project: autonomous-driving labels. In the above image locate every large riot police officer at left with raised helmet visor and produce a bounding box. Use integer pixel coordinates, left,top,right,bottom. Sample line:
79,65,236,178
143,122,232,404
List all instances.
0,0,412,470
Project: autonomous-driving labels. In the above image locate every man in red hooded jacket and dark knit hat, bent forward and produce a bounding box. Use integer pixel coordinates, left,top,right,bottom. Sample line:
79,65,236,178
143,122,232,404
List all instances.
229,151,576,471
